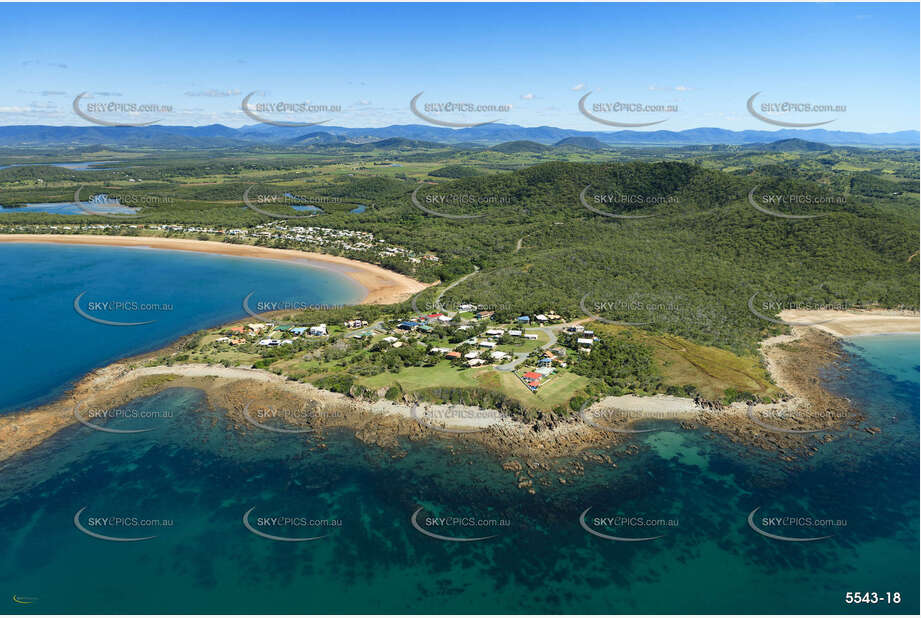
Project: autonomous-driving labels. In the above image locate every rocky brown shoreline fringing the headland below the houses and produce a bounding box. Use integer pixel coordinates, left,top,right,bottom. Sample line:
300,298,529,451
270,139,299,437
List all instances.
0,312,916,470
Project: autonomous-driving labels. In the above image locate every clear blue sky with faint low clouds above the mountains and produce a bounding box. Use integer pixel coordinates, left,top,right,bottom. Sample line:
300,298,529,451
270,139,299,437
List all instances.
0,3,921,132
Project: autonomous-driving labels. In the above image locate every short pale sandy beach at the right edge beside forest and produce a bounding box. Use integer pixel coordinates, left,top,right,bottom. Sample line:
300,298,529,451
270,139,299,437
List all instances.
780,309,921,337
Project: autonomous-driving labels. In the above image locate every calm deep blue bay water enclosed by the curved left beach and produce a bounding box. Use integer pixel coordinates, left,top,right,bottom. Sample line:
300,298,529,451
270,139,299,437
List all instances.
0,243,363,413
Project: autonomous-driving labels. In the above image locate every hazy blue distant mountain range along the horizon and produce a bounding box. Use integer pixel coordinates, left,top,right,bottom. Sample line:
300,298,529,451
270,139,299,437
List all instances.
0,123,921,150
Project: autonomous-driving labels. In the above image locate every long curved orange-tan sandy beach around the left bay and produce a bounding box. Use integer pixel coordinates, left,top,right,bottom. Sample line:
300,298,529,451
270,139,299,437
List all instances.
0,234,428,305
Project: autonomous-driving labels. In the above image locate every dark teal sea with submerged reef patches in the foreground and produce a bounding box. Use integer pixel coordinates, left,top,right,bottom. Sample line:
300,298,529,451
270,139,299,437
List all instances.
0,248,919,614
